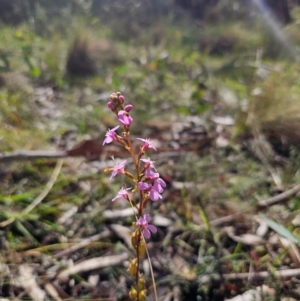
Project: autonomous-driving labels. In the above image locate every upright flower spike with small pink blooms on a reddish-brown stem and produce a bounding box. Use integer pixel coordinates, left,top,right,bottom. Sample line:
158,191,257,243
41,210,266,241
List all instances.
103,92,166,301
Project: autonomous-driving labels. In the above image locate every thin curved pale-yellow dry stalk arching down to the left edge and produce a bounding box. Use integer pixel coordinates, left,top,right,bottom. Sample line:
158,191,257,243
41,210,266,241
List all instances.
0,159,63,227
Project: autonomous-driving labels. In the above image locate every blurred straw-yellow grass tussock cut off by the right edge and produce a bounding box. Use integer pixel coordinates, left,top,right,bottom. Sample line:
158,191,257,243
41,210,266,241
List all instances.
247,64,300,144
